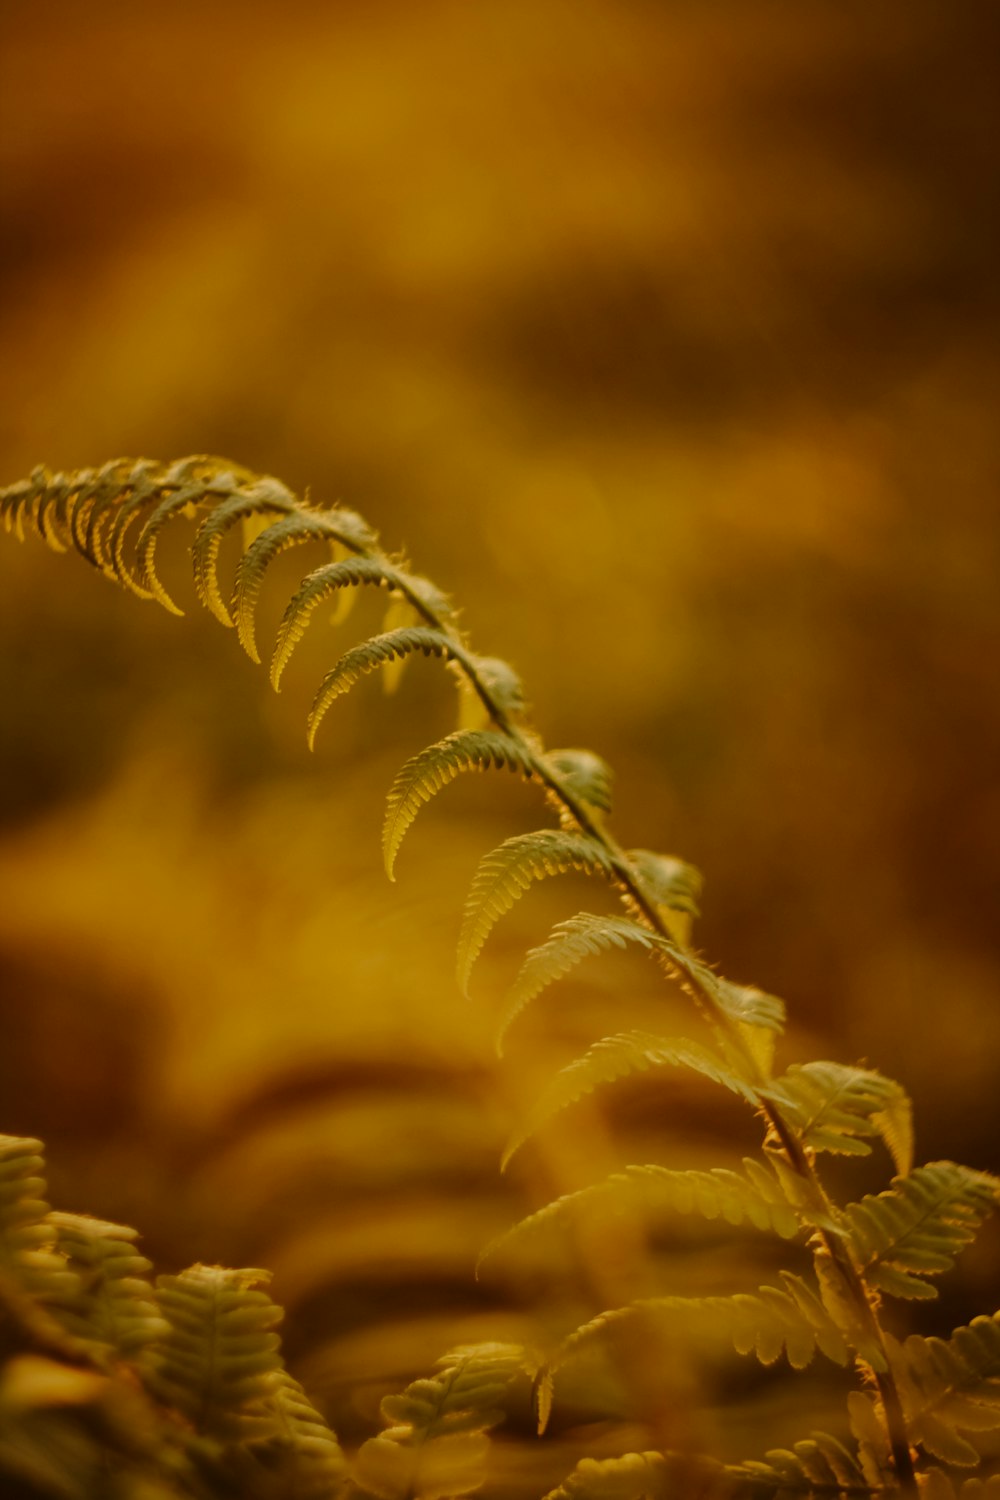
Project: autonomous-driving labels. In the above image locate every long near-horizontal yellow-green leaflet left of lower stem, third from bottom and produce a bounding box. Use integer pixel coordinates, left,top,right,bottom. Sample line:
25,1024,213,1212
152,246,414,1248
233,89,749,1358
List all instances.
480,1157,801,1265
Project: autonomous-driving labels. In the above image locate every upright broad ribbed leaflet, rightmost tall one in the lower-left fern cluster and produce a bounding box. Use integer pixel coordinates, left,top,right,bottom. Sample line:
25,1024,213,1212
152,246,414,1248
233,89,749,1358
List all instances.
144,1266,282,1442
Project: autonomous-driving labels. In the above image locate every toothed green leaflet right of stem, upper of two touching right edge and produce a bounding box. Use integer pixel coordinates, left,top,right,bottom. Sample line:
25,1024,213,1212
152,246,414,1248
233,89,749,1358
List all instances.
843,1161,1000,1298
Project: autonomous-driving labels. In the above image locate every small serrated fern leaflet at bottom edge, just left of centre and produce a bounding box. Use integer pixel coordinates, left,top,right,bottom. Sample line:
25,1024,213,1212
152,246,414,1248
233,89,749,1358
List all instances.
352,1344,525,1500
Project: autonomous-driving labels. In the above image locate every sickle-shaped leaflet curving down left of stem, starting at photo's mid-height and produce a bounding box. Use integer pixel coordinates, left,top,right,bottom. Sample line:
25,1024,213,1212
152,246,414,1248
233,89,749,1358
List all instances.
382,729,538,881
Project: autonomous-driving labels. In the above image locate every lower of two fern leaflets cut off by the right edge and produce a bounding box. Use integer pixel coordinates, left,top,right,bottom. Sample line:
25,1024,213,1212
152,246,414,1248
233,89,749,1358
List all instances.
889,1313,1000,1467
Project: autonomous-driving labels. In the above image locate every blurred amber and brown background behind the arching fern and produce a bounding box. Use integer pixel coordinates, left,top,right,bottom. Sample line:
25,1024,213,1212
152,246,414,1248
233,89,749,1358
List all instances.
0,0,1000,1493
